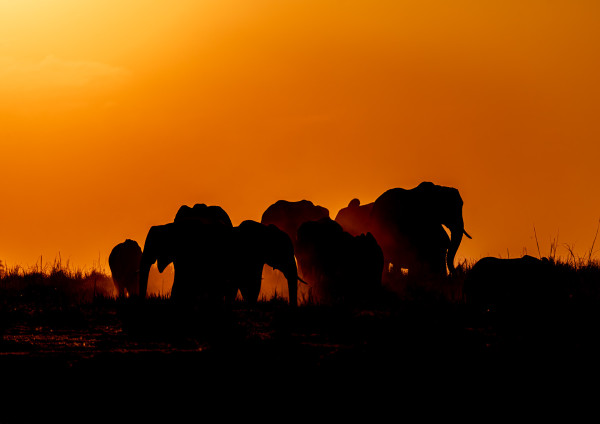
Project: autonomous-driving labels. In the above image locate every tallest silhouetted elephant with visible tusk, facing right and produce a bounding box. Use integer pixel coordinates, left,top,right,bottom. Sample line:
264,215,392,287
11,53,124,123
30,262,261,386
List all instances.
368,182,471,275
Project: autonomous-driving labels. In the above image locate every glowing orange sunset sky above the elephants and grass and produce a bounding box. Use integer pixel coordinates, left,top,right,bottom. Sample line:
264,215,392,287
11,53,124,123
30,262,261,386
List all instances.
0,0,600,267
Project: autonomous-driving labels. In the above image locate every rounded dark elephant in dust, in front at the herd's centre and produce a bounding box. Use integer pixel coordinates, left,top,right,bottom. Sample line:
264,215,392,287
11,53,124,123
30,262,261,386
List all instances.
296,218,383,303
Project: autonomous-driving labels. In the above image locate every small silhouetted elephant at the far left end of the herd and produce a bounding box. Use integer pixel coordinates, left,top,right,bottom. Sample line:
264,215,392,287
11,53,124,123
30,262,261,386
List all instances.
108,239,142,297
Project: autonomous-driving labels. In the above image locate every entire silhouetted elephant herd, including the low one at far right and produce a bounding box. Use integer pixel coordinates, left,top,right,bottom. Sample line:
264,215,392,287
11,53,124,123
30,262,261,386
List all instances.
109,182,572,312
